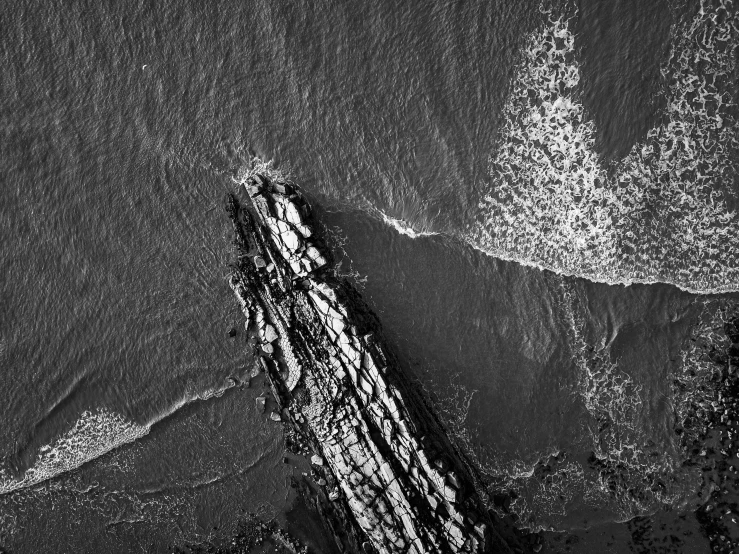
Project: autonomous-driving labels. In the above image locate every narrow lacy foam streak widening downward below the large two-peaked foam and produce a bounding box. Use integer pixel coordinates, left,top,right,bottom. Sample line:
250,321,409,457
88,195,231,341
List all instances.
560,281,694,521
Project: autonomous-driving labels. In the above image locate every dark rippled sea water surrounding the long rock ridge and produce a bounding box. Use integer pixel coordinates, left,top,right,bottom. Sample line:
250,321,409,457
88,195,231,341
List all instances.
0,0,739,553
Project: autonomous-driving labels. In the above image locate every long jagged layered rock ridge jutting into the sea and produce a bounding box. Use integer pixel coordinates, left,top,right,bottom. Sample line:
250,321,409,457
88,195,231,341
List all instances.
228,174,508,554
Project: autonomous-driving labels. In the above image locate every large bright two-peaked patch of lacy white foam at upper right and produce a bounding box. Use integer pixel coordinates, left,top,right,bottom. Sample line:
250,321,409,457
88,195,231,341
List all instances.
474,0,739,293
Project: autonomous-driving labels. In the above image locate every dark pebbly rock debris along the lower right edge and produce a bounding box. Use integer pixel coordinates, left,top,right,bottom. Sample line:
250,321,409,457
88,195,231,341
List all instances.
673,299,739,554
